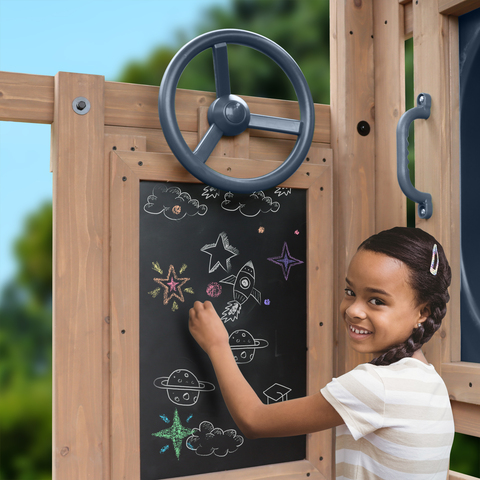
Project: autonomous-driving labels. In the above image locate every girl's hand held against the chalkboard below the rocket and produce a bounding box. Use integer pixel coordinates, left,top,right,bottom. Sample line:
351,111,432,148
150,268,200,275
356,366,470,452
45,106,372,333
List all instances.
188,301,230,356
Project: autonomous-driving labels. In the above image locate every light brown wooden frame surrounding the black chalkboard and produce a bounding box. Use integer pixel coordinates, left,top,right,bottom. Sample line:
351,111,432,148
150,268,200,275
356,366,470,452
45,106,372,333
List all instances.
111,151,333,480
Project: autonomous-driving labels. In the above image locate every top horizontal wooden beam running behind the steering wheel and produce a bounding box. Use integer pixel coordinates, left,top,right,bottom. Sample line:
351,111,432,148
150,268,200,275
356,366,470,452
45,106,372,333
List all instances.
0,72,330,144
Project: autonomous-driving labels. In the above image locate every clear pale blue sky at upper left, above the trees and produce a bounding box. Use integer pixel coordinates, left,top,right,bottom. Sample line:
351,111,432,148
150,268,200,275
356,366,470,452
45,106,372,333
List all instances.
0,0,230,288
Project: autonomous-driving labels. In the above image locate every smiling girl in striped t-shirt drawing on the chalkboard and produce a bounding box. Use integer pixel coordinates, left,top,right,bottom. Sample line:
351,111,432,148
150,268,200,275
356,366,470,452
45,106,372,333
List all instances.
189,227,454,480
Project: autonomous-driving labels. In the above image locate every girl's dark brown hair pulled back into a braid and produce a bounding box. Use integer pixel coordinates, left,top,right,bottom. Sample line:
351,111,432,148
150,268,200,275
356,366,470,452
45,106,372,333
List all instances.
358,227,452,365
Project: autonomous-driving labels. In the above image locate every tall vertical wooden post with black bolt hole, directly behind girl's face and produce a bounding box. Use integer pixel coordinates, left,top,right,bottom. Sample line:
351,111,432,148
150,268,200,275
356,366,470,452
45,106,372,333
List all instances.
330,2,375,375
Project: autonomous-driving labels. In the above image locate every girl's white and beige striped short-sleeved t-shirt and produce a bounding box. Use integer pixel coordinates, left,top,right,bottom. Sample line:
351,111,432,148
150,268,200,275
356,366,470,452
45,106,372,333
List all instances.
321,358,455,480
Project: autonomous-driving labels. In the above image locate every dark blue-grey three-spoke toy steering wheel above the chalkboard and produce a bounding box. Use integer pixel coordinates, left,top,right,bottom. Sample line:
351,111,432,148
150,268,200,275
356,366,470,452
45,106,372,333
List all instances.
158,29,315,193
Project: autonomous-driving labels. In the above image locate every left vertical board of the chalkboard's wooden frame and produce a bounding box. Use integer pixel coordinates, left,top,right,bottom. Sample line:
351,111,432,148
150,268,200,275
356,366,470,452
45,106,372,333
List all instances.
110,151,140,480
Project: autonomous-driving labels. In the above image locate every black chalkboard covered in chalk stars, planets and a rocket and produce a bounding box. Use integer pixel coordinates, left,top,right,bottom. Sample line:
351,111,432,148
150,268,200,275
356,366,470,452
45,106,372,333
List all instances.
140,181,307,480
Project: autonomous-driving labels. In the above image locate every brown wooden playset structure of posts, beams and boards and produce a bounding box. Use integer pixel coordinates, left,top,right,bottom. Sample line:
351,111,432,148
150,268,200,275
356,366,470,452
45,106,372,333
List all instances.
0,0,480,480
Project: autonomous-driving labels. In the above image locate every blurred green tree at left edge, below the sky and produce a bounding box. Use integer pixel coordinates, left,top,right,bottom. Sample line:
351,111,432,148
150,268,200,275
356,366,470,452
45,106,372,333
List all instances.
0,202,52,480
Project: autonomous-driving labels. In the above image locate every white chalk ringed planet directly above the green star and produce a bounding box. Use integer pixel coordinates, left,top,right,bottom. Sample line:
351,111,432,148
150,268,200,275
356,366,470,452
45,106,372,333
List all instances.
153,369,215,407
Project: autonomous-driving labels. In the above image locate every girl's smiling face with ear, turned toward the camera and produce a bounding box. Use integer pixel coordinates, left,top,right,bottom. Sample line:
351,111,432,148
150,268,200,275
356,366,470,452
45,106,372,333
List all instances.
340,250,429,355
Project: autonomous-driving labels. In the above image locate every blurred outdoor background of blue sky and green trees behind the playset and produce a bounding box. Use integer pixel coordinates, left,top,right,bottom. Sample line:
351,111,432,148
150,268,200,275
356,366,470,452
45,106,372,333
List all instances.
0,0,480,480
